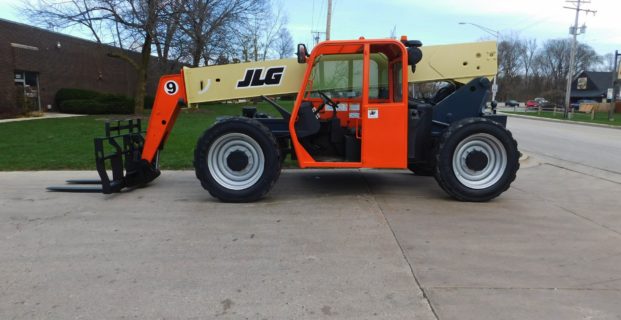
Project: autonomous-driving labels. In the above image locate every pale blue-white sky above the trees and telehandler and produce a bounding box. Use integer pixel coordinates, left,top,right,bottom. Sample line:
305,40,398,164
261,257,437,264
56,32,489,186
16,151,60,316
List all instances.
0,0,621,54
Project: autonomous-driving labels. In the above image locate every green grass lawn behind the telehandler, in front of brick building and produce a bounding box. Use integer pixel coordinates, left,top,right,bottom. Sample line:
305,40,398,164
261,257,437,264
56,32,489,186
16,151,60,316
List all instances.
0,101,293,171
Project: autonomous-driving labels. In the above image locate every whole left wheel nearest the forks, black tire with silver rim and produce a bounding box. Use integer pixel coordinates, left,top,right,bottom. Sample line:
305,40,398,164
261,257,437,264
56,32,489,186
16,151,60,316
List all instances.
194,117,282,202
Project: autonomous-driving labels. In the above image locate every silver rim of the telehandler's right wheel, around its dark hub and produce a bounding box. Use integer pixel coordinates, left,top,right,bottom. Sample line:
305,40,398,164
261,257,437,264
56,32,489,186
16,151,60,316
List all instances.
453,133,507,190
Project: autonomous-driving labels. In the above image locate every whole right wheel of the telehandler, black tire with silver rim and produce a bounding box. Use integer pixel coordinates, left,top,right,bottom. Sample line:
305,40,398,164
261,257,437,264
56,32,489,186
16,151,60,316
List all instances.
435,118,520,202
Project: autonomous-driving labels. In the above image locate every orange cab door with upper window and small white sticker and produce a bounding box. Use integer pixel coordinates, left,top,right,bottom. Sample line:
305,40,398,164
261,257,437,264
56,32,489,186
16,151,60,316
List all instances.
360,43,408,168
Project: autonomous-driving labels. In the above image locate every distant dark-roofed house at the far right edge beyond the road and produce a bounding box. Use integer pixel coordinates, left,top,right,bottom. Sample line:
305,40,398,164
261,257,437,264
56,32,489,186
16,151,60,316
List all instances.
571,71,612,102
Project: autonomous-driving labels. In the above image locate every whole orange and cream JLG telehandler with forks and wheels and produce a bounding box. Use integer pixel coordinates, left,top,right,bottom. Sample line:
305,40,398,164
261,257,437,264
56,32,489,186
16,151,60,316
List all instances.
49,36,519,202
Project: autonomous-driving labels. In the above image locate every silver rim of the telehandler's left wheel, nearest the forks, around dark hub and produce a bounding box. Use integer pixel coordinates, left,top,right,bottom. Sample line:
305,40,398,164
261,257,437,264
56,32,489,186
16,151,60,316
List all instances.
207,133,265,190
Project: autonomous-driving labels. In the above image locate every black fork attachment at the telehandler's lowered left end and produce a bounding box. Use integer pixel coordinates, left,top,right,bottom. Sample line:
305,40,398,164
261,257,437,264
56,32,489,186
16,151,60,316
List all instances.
47,119,160,194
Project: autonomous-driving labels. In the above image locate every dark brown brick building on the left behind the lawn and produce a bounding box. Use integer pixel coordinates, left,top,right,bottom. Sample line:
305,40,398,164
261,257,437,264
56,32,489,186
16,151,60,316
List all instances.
0,19,174,118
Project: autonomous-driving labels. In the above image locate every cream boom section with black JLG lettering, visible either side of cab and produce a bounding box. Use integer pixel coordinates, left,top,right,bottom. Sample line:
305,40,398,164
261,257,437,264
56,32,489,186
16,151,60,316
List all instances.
183,39,497,104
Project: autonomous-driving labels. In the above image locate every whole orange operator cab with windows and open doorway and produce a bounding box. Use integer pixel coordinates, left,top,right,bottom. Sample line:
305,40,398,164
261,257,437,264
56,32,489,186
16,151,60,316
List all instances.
290,39,420,168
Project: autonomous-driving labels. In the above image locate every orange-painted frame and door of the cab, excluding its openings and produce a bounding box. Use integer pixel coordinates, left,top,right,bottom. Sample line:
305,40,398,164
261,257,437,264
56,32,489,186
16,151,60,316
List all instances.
289,39,408,168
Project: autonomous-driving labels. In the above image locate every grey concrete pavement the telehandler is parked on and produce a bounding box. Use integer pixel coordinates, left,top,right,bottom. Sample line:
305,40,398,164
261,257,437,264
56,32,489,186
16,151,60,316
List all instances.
0,161,621,320
